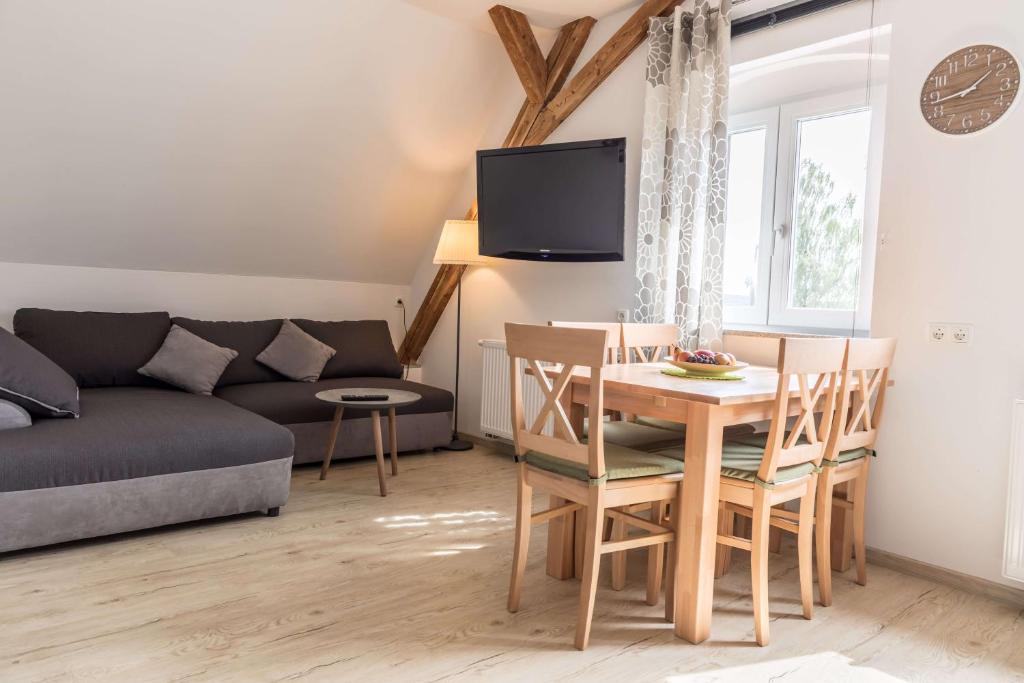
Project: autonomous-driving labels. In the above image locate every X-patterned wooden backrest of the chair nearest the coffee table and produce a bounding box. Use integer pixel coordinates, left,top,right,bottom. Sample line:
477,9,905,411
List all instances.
505,323,608,479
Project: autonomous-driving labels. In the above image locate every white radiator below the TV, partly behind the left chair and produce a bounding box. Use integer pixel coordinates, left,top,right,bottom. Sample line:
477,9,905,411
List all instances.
480,339,551,440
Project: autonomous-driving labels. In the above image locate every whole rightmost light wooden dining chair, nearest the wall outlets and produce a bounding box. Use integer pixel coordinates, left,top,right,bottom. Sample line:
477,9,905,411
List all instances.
815,339,896,605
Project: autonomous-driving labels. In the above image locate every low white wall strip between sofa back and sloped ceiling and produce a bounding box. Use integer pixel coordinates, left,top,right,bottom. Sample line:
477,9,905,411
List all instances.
0,263,410,342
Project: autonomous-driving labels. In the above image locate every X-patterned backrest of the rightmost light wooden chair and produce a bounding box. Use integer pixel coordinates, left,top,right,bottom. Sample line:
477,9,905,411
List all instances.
825,338,896,460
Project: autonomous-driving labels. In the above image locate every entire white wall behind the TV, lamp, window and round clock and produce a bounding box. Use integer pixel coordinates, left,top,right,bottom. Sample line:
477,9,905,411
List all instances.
413,0,1024,583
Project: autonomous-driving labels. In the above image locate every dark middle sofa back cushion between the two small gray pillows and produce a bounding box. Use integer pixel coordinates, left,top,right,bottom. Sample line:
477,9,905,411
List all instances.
171,317,288,387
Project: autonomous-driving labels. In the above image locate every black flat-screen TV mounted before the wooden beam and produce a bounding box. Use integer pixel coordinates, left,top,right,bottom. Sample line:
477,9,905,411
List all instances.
476,138,626,261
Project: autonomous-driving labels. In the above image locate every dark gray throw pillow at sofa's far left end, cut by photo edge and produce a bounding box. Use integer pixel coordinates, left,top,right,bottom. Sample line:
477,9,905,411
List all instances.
0,328,79,418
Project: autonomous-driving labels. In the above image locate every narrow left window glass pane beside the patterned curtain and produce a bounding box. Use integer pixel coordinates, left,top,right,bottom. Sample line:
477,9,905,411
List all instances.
722,128,767,306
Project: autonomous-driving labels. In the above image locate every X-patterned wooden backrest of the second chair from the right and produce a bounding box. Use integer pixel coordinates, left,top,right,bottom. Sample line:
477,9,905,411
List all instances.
758,337,846,481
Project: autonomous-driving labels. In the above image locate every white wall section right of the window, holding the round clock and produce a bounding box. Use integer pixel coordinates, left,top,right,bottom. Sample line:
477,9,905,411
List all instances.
868,0,1024,586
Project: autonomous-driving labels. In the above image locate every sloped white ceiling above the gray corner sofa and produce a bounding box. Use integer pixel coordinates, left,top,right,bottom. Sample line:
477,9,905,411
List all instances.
0,0,518,284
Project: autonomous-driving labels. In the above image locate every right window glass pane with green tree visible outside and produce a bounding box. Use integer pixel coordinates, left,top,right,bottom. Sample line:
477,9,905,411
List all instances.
786,110,871,310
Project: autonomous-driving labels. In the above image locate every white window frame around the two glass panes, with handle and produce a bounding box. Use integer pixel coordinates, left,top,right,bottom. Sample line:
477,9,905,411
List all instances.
723,87,886,332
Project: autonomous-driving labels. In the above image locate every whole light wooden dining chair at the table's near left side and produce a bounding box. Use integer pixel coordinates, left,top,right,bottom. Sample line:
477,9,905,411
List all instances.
505,323,683,649
